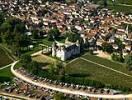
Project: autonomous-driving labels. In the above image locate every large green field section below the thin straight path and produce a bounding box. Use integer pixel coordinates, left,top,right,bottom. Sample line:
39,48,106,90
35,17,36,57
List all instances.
66,59,132,88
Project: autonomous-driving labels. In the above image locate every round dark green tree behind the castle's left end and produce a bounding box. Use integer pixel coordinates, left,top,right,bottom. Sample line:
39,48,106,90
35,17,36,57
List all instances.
48,28,60,40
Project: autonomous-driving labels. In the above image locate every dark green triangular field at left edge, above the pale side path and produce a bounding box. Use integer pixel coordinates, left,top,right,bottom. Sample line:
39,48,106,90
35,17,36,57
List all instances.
0,47,12,67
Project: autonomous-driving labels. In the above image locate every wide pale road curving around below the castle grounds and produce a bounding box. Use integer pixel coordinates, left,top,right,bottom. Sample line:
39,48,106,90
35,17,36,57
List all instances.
11,61,132,100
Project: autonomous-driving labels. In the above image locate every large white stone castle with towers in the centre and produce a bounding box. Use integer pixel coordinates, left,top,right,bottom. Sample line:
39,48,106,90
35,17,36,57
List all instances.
52,40,80,61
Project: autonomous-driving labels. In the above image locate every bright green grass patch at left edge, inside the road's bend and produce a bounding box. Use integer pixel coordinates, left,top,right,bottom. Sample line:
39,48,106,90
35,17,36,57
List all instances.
0,67,14,83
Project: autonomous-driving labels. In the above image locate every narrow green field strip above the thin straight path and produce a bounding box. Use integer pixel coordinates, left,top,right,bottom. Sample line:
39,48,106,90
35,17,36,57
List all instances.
82,54,132,75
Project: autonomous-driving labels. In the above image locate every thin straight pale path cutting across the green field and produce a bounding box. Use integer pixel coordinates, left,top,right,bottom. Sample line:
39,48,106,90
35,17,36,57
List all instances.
80,57,132,78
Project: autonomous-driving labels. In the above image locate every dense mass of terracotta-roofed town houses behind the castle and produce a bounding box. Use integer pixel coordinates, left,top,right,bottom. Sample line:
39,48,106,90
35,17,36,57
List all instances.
0,0,132,60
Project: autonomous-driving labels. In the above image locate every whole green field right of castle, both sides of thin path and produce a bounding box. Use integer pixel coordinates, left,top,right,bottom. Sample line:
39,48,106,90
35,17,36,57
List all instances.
66,55,132,88
